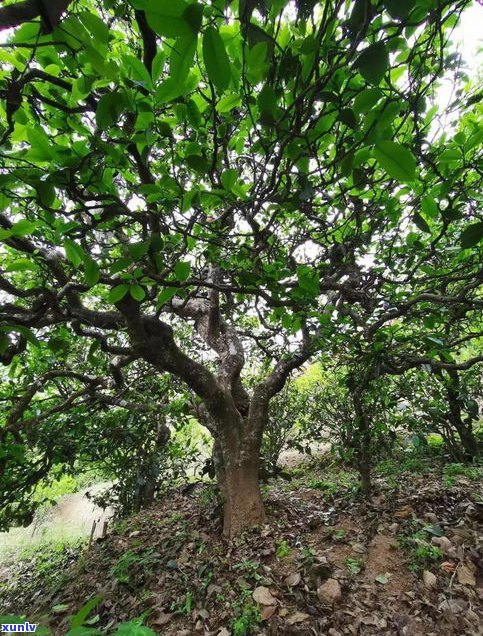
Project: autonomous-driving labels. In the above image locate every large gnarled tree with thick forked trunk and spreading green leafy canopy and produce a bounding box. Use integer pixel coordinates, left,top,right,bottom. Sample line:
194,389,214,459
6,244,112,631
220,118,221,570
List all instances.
0,0,483,534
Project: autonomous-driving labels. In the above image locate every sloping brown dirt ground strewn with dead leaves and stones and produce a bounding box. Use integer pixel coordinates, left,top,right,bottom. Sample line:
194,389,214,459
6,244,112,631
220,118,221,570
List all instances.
0,458,483,636
